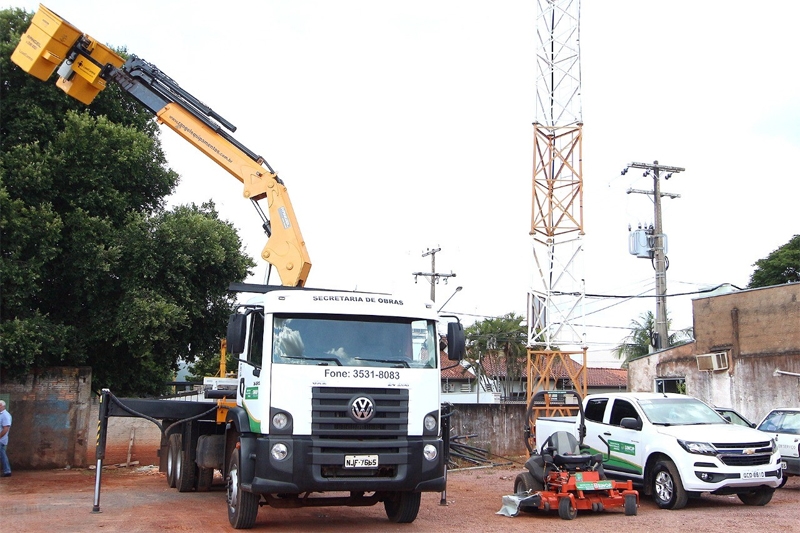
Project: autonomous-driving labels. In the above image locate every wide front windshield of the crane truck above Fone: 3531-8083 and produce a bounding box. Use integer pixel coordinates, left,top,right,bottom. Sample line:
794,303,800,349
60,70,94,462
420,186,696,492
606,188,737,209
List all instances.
272,315,438,368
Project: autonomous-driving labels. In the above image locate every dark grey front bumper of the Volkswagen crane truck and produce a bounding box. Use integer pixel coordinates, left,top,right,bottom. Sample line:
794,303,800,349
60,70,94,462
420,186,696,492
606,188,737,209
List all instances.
241,436,446,494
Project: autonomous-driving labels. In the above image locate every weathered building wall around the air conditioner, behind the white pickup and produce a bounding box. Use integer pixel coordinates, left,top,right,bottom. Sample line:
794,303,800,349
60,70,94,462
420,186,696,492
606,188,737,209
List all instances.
628,283,800,422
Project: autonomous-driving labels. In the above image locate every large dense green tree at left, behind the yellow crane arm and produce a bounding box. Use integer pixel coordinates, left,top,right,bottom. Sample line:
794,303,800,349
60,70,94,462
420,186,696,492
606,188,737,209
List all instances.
0,9,254,395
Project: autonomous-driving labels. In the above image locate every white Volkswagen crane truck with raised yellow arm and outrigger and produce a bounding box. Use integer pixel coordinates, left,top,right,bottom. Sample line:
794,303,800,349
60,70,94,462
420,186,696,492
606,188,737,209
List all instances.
12,5,465,529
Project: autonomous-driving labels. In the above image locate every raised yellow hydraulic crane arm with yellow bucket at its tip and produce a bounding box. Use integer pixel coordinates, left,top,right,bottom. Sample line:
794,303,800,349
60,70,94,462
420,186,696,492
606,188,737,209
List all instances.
11,4,311,287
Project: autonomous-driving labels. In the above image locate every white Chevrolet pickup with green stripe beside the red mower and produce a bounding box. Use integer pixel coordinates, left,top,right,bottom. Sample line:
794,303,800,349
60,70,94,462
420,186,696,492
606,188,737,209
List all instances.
536,393,782,509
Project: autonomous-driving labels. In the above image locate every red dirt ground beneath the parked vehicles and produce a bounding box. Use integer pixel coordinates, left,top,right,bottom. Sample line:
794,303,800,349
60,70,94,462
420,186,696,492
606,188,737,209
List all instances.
0,464,800,533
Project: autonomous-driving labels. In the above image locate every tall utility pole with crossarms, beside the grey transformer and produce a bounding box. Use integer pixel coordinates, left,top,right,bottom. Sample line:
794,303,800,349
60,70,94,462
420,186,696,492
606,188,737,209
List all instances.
622,161,686,350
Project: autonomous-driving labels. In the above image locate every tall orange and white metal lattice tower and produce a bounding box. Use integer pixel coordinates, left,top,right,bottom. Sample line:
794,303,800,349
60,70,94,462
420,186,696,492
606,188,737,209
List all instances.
528,0,587,448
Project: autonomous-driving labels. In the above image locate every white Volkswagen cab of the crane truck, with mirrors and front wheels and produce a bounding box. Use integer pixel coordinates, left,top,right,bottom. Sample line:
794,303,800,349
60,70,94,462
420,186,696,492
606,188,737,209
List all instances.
219,287,463,527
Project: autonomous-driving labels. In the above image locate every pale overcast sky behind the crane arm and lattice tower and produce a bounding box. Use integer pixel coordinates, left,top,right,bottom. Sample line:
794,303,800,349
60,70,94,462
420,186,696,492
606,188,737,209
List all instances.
3,0,800,366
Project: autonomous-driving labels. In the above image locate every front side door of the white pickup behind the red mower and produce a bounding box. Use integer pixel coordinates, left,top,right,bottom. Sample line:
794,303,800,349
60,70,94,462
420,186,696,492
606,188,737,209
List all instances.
597,398,644,477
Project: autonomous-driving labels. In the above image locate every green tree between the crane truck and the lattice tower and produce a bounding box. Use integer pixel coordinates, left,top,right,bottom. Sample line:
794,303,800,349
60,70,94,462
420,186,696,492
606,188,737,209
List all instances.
465,313,528,398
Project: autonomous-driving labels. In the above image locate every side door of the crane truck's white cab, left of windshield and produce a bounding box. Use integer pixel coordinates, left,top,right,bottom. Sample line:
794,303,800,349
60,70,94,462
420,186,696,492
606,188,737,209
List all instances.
236,310,269,433
